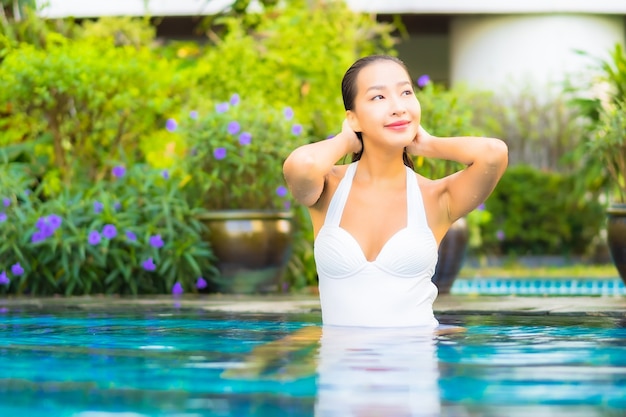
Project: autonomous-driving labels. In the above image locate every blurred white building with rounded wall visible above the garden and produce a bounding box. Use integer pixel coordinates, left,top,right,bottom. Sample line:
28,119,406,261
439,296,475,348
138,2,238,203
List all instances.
36,0,626,91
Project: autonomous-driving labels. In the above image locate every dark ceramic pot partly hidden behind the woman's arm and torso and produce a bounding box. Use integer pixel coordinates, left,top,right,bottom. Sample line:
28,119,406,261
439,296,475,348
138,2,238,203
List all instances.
432,217,469,294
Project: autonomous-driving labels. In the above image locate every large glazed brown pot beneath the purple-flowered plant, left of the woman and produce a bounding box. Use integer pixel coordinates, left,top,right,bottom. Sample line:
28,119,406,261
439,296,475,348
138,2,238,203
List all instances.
200,210,293,294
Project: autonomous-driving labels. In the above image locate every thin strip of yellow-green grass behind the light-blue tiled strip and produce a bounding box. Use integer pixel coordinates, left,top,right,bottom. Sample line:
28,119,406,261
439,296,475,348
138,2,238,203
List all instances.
459,263,619,278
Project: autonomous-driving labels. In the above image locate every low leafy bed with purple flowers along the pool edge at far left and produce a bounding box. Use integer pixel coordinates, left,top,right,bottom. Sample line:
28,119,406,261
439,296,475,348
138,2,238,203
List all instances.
0,164,215,295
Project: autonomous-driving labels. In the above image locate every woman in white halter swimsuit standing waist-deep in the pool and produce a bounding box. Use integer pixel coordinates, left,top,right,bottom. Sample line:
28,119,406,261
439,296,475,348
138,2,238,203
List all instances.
283,55,508,328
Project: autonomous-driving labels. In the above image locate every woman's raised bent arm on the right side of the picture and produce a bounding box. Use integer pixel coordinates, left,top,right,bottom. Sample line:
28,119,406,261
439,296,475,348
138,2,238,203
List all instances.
409,126,508,222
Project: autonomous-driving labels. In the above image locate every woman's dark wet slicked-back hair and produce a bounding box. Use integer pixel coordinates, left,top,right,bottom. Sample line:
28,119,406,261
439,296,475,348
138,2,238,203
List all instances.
341,55,415,169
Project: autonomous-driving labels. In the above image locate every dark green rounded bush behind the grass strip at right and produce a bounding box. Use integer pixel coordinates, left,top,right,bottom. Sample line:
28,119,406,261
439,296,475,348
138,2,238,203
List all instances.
482,165,605,255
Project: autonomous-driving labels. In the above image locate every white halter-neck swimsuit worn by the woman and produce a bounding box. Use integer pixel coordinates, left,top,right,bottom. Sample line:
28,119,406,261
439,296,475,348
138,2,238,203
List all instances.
314,162,439,328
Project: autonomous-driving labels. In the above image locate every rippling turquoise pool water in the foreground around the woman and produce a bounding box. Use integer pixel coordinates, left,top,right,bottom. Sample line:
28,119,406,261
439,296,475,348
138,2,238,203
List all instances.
0,307,626,417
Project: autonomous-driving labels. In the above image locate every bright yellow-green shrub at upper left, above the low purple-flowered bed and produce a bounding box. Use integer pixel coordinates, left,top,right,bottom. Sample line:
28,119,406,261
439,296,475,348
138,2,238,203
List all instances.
0,35,184,194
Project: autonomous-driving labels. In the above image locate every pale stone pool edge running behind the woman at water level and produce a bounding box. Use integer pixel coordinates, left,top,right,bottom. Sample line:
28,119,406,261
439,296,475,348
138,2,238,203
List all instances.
0,294,626,318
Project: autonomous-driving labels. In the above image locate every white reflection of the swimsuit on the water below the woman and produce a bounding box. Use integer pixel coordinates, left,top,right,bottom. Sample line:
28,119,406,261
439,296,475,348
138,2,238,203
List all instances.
315,326,441,417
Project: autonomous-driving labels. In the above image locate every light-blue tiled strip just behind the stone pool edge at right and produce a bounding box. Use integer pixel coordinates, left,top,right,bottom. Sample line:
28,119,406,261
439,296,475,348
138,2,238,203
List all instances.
450,278,626,295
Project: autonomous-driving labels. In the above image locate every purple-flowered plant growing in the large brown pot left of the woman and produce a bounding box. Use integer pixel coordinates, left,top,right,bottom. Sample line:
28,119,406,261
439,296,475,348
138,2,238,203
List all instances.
165,94,304,210
